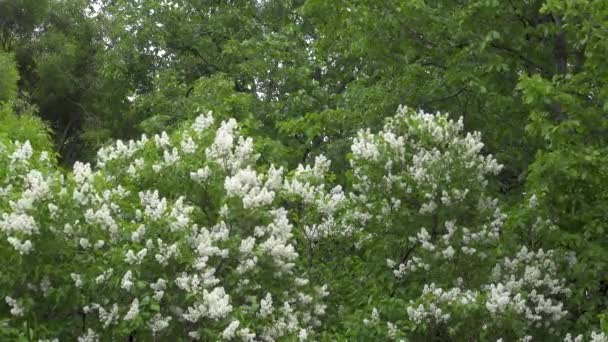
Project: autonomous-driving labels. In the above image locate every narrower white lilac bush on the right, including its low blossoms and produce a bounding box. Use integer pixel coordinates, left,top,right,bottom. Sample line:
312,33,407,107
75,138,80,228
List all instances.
349,107,600,340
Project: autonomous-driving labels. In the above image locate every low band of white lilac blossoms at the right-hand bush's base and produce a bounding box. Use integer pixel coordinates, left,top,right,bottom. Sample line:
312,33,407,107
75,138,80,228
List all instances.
400,247,582,338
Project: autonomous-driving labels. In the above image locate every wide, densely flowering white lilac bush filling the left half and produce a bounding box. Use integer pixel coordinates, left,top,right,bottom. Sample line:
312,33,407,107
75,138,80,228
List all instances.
0,115,332,341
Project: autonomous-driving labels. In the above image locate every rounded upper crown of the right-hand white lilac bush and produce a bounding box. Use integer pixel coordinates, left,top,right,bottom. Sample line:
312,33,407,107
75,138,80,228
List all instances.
350,107,506,279
